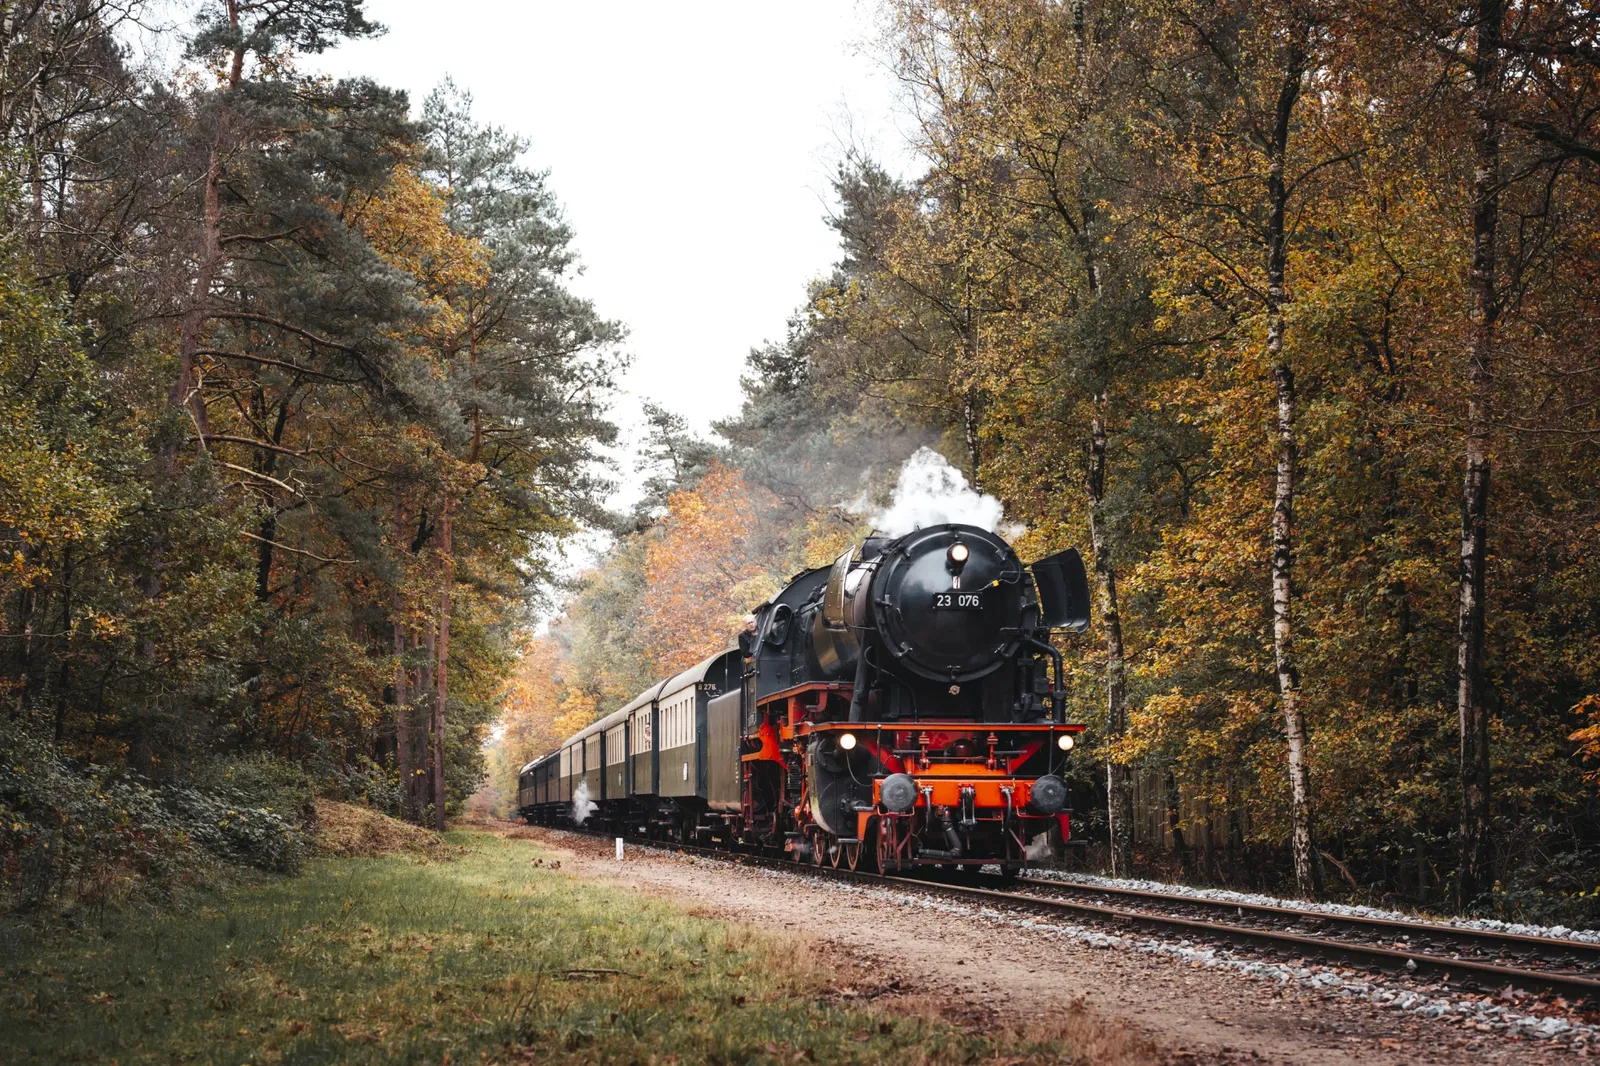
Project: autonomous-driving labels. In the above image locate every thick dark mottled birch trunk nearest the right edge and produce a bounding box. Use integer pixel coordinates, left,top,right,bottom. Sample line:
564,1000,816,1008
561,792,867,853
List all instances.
1456,0,1504,906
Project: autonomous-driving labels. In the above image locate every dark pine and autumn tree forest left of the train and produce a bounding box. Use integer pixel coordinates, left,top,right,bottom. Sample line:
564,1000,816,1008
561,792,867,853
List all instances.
0,0,622,908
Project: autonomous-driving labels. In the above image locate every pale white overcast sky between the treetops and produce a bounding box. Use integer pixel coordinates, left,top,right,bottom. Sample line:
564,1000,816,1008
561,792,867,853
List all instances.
320,0,909,464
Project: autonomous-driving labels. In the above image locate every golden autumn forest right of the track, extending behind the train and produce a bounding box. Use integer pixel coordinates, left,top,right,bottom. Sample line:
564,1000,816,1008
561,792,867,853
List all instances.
496,0,1600,920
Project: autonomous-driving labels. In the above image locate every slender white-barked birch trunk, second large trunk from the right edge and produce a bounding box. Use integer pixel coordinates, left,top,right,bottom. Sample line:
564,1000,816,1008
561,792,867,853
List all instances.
1267,45,1322,900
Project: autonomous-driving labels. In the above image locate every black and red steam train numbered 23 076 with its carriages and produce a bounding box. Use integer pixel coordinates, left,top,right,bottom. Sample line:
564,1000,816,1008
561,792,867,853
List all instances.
517,523,1088,872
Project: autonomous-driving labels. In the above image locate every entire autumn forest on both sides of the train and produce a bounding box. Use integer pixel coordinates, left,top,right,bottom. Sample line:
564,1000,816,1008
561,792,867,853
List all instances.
9,0,1600,922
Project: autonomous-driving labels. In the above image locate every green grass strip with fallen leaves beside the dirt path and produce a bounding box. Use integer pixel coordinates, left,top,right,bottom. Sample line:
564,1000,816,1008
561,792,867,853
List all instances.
0,832,1100,1066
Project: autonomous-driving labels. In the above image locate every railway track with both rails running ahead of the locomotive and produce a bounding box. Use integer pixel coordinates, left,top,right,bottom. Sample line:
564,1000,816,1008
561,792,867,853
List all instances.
582,825,1600,1007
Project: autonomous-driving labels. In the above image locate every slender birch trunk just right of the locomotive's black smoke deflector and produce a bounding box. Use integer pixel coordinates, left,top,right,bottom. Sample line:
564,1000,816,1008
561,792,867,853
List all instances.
1085,411,1133,877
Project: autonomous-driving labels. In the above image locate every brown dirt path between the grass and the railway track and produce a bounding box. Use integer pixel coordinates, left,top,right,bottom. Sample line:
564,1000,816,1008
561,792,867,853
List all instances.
510,829,1594,1066
